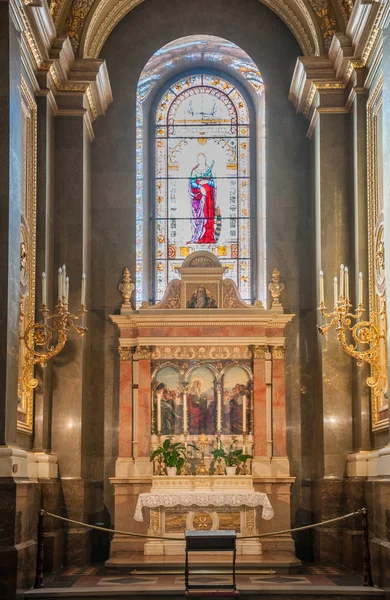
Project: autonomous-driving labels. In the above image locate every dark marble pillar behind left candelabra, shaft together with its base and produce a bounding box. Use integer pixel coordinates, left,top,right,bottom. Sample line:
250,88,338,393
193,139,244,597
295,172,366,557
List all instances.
51,113,92,565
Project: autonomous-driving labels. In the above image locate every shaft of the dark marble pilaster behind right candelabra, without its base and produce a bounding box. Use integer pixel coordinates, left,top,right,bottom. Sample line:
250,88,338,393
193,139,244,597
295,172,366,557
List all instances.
314,113,353,478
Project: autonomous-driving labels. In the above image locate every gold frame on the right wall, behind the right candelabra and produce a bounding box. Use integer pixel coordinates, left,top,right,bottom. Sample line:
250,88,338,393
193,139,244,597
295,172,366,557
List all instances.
367,74,389,431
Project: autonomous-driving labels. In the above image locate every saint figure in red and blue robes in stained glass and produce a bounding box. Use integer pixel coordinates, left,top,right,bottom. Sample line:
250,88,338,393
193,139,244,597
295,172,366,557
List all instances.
188,152,216,244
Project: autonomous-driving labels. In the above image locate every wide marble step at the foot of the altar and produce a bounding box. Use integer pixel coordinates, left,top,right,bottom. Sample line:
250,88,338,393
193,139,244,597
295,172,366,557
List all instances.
105,551,302,575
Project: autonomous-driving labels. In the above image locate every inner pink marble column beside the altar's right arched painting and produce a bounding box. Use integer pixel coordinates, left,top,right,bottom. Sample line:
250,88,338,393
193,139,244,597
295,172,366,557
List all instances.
250,346,267,456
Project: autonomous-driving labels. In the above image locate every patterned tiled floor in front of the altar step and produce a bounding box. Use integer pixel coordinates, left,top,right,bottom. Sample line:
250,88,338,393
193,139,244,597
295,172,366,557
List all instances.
39,565,362,592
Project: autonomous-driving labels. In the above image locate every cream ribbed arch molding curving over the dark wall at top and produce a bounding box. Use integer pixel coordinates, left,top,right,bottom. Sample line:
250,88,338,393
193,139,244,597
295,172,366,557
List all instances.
64,0,324,58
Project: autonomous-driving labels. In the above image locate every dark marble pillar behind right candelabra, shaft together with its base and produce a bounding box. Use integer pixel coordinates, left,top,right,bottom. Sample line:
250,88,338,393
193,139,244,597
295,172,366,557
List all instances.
313,107,354,562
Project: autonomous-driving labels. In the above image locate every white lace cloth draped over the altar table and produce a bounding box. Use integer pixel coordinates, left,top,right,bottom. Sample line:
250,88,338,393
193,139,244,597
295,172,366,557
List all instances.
134,492,274,522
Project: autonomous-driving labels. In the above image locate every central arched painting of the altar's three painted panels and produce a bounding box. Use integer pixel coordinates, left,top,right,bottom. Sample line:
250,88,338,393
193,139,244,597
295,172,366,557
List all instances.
187,366,217,435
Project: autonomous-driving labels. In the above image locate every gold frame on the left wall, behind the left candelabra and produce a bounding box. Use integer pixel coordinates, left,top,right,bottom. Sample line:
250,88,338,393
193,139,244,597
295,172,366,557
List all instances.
17,75,37,435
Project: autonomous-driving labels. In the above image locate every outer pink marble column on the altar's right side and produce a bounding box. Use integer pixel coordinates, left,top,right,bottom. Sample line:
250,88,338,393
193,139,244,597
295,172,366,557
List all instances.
271,346,287,456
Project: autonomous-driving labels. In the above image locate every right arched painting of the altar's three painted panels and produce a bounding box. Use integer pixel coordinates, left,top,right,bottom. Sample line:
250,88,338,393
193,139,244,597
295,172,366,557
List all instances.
222,367,250,435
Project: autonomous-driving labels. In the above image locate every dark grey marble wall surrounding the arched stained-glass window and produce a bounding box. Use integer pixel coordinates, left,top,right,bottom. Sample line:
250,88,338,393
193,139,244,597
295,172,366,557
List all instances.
89,0,316,552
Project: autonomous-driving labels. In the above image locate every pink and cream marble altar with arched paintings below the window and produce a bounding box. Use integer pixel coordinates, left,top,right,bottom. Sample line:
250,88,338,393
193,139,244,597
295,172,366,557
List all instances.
108,252,296,566
